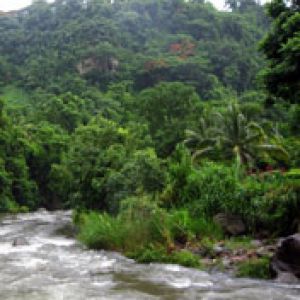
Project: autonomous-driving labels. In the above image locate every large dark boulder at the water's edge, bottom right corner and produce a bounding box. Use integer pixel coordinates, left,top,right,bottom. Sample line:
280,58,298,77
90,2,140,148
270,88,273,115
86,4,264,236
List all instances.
270,233,300,282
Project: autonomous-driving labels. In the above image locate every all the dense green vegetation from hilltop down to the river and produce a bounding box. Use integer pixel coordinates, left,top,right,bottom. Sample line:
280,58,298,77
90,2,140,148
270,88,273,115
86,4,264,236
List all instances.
0,0,300,276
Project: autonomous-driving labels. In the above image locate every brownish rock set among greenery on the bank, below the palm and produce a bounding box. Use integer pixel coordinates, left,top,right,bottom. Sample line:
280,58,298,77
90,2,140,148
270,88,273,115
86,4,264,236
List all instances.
214,213,246,236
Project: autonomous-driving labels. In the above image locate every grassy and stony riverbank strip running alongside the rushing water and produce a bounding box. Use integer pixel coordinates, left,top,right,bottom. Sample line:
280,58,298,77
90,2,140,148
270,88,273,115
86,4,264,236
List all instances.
75,211,277,279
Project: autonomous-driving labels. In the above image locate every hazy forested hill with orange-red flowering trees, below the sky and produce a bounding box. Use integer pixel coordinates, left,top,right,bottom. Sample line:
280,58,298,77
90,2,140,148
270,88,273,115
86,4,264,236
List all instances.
0,0,269,100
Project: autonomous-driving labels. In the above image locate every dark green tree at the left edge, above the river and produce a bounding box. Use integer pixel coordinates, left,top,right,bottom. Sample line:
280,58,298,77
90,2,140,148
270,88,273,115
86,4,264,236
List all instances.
0,100,39,211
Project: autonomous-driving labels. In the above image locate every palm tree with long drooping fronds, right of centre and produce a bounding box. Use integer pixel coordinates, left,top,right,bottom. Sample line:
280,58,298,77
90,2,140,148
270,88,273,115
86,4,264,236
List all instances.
186,102,288,169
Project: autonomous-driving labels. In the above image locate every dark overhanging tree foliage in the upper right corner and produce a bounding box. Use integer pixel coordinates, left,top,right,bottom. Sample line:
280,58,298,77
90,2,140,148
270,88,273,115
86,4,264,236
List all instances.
261,0,300,103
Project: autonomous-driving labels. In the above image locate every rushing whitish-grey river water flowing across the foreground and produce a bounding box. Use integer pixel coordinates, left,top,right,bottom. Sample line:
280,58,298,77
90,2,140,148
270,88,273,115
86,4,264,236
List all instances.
0,212,300,300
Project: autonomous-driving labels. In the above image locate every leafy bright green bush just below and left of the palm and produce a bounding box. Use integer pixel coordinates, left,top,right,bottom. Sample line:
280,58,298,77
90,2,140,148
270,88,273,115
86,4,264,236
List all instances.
161,158,241,218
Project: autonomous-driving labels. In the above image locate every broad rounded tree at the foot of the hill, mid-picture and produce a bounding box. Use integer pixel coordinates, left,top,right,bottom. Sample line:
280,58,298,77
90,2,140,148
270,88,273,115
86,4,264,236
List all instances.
138,82,200,156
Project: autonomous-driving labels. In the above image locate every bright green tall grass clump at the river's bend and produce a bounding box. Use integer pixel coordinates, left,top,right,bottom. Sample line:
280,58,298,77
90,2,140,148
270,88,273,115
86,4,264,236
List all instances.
74,197,207,267
